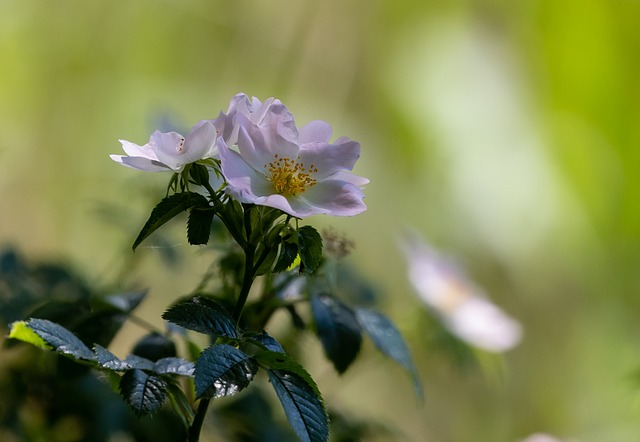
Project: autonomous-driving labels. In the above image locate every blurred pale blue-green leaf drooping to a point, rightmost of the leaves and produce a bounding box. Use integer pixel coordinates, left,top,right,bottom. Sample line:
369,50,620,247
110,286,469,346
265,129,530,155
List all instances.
356,308,423,398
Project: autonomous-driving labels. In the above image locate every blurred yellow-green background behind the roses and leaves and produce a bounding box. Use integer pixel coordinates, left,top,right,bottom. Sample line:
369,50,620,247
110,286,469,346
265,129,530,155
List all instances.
0,0,640,442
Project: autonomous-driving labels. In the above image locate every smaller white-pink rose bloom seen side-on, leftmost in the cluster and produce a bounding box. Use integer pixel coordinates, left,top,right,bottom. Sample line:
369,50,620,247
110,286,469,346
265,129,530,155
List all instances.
110,121,217,173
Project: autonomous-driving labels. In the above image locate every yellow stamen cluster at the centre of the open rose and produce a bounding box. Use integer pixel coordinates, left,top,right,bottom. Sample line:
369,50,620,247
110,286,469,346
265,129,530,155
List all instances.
264,154,318,196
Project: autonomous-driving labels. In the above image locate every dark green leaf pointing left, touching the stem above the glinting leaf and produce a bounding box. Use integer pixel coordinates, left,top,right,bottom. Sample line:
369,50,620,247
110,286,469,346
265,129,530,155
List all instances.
162,296,238,338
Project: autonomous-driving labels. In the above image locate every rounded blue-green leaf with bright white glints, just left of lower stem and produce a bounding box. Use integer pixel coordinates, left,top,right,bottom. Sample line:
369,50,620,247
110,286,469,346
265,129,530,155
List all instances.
195,344,258,398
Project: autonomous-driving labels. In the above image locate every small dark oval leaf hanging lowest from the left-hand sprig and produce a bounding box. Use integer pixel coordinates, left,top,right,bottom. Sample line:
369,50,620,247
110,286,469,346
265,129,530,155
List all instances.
120,369,167,416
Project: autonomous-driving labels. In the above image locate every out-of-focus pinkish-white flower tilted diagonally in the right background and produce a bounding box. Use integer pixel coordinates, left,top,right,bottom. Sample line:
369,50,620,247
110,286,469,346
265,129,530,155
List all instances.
402,235,522,352
